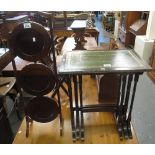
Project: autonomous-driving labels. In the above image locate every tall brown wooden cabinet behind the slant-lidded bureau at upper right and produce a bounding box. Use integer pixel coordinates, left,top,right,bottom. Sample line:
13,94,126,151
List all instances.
119,11,142,46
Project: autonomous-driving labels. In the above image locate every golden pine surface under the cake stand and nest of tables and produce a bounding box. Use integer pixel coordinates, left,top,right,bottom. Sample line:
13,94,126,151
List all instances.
13,76,138,144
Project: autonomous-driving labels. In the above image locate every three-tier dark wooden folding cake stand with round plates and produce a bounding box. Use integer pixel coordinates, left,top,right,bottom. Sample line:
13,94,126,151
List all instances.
9,20,63,137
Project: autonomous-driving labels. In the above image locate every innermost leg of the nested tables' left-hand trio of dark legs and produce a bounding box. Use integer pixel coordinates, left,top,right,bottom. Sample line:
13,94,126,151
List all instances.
79,75,84,141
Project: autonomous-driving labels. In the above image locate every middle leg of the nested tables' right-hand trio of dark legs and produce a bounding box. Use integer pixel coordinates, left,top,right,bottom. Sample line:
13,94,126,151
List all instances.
123,74,133,139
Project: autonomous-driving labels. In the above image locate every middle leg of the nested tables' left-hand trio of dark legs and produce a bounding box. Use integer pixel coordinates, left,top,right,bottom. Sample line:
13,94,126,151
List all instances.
73,75,80,139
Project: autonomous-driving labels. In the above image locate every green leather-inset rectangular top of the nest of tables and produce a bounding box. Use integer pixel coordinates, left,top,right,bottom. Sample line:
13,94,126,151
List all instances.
59,50,151,74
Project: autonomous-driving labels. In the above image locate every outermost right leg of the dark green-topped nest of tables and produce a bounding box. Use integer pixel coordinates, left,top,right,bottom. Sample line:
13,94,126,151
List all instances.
126,73,139,138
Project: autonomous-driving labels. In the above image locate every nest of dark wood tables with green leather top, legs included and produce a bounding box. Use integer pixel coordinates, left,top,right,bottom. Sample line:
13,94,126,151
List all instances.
58,50,151,140
